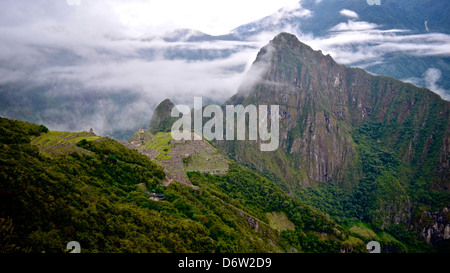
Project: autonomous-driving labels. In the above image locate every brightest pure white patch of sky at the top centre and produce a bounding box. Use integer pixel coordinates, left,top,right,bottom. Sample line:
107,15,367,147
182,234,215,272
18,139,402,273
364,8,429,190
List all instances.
107,0,299,35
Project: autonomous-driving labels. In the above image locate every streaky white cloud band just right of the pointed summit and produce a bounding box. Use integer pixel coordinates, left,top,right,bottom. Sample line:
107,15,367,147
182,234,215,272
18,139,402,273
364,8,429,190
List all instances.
298,20,450,66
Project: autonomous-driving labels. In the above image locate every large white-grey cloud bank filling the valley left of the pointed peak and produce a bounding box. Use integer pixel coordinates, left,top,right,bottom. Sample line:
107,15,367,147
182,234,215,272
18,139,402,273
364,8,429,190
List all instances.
0,1,263,135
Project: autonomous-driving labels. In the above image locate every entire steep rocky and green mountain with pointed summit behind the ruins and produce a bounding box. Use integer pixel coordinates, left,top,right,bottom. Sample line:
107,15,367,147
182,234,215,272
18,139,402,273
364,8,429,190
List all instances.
216,33,450,248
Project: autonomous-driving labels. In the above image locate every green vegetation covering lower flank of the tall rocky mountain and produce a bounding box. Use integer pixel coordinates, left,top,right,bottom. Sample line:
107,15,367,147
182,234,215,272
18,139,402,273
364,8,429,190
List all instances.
298,120,450,252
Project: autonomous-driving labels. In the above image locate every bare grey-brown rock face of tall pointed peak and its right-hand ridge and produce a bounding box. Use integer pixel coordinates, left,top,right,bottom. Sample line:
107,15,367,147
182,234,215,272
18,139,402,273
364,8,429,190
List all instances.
219,33,450,188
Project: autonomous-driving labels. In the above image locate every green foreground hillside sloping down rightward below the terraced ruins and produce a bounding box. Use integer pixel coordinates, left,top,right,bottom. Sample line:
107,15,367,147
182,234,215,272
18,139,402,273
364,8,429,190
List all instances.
0,118,365,252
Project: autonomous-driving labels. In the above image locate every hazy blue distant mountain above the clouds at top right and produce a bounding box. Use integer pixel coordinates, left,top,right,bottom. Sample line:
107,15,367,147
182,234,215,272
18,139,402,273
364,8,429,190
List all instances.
232,0,450,36
